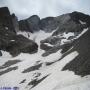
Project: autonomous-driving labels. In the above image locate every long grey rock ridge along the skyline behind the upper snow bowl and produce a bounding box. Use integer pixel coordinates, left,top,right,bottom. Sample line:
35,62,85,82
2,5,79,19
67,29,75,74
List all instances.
19,12,90,35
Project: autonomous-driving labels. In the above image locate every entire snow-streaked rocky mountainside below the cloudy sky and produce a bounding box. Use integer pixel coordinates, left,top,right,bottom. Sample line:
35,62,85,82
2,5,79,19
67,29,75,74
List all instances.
0,7,90,90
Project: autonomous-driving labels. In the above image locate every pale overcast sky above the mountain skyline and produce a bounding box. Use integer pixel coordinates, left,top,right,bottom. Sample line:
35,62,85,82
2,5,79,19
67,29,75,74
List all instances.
0,0,90,19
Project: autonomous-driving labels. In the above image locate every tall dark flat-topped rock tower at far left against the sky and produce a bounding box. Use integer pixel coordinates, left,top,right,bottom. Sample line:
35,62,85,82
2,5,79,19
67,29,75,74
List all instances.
0,7,15,32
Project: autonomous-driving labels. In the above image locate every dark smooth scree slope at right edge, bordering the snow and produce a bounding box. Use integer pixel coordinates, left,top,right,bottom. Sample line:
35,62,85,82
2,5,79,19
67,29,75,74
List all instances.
63,29,90,76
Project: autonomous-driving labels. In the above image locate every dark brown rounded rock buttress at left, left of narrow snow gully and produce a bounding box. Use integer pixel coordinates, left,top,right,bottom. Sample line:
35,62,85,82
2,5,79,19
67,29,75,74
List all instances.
0,29,38,56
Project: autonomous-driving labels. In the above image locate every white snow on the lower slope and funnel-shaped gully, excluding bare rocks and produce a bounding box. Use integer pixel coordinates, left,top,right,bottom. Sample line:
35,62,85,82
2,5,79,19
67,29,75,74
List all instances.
0,29,90,90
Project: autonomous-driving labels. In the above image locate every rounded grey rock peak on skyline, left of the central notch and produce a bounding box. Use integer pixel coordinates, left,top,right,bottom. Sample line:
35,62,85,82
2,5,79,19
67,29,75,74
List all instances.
19,15,40,32
